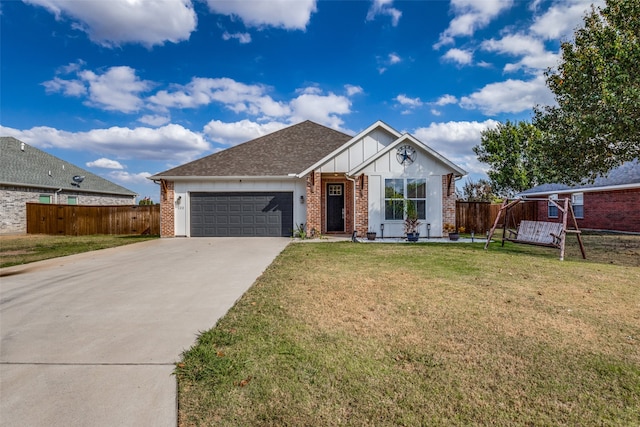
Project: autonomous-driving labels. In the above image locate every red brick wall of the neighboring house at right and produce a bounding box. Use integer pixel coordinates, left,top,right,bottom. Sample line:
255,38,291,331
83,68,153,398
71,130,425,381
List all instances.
538,188,640,233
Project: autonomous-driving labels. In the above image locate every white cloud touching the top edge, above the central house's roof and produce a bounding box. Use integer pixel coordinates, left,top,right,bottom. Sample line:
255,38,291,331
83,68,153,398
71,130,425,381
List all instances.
207,0,317,30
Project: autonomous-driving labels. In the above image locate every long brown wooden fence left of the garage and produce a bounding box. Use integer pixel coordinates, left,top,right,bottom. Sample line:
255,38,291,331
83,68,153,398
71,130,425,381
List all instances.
27,203,160,236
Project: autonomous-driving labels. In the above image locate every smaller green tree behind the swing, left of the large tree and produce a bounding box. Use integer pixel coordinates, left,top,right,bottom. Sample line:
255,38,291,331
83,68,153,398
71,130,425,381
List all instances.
473,120,547,197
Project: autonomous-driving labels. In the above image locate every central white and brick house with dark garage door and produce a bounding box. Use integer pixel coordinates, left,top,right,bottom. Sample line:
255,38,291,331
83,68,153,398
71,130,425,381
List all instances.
149,121,466,237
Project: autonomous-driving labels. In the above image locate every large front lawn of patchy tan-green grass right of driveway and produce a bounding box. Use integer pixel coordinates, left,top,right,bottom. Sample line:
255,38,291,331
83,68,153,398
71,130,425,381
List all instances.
175,236,640,426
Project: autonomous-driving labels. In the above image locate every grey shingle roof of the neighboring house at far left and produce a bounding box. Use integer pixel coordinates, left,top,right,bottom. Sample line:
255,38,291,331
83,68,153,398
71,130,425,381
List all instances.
0,136,136,197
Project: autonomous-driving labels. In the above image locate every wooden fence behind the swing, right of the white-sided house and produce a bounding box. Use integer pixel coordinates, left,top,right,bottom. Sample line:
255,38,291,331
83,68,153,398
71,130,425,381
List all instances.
456,201,538,234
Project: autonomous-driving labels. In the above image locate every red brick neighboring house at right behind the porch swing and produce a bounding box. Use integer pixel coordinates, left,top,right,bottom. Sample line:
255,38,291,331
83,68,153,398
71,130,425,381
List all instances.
518,160,640,233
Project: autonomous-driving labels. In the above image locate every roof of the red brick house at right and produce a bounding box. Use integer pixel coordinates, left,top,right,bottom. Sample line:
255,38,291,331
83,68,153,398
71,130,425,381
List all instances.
519,159,640,196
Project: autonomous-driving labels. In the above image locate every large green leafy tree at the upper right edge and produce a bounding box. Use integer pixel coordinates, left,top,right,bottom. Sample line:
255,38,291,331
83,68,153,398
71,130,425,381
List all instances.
534,0,640,183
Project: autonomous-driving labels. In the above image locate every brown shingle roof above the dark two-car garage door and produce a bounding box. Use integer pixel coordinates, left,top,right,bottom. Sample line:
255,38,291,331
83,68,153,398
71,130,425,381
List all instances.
149,120,351,179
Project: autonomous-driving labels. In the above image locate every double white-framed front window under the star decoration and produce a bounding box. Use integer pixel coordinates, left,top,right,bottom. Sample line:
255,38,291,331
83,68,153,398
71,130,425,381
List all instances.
384,178,427,220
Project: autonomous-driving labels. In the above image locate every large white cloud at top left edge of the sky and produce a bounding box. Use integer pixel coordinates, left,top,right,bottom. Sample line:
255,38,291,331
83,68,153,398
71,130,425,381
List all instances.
24,0,197,47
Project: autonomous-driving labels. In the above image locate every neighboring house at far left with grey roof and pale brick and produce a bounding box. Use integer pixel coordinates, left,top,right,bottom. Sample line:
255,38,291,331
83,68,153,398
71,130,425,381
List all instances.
0,137,136,234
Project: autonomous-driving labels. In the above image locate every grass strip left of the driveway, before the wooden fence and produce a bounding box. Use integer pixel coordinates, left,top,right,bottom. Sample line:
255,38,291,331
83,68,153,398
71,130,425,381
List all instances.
0,234,158,268
